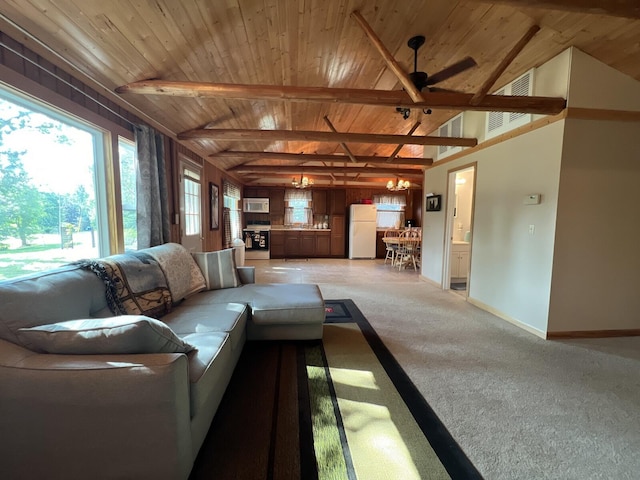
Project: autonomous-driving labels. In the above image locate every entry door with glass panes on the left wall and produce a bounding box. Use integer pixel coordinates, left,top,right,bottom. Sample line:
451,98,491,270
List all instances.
180,161,204,252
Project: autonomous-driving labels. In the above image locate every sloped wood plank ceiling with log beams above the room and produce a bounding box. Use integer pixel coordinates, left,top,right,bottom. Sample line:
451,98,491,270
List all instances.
0,0,640,186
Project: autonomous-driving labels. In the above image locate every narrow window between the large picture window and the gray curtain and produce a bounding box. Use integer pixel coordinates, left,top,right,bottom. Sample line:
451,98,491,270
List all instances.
118,137,138,251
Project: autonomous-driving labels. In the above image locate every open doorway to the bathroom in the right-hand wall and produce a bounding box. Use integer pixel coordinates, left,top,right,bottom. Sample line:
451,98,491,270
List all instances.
442,164,476,297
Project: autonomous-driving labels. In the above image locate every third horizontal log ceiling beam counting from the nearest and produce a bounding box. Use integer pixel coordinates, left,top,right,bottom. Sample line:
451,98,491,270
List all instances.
209,150,433,166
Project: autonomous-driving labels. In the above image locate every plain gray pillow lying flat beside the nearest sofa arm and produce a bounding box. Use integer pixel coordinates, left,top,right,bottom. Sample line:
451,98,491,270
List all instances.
18,315,195,355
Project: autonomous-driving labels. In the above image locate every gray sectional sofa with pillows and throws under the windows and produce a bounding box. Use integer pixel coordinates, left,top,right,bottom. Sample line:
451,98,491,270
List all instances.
0,244,325,479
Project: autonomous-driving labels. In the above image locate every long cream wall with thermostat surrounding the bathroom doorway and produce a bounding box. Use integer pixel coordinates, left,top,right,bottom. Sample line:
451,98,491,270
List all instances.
422,122,564,332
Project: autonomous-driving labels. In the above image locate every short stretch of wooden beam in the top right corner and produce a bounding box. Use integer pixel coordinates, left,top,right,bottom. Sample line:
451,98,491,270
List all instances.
462,0,640,18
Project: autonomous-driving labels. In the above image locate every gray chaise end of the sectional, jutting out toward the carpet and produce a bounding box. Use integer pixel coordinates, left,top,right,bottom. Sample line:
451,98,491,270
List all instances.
247,283,325,340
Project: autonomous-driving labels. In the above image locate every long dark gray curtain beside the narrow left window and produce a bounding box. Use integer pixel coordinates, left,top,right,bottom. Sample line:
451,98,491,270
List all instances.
134,125,171,249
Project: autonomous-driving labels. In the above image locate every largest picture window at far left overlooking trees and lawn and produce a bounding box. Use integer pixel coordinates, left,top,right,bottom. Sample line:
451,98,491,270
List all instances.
0,88,109,280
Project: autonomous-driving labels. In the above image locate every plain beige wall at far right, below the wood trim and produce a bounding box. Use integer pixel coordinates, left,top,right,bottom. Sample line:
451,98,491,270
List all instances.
549,125,640,332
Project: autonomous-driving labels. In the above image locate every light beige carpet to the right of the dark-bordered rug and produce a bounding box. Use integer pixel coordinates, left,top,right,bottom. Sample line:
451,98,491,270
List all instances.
320,280,640,480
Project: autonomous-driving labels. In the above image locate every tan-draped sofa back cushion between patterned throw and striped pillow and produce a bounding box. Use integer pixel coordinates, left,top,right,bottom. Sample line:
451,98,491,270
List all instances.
143,243,206,302
